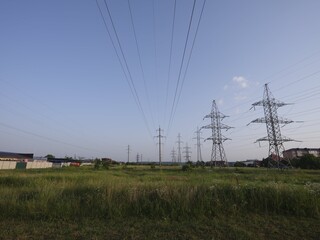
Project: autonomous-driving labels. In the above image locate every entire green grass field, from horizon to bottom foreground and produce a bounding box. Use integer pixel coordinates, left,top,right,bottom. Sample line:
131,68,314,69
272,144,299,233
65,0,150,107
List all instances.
0,166,320,240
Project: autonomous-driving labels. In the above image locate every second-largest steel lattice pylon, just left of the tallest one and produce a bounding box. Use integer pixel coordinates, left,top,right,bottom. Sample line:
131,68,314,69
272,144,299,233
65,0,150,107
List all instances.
201,100,231,166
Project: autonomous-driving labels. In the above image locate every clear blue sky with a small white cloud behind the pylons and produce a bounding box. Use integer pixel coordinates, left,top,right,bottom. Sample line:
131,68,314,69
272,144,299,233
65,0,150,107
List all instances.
0,0,320,161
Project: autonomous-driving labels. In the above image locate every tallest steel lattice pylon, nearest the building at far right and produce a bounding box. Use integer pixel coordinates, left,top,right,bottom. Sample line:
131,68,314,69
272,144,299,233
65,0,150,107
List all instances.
249,84,295,168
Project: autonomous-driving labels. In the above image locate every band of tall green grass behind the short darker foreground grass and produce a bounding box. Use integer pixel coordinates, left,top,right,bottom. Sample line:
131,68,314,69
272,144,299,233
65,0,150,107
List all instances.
0,167,320,219
